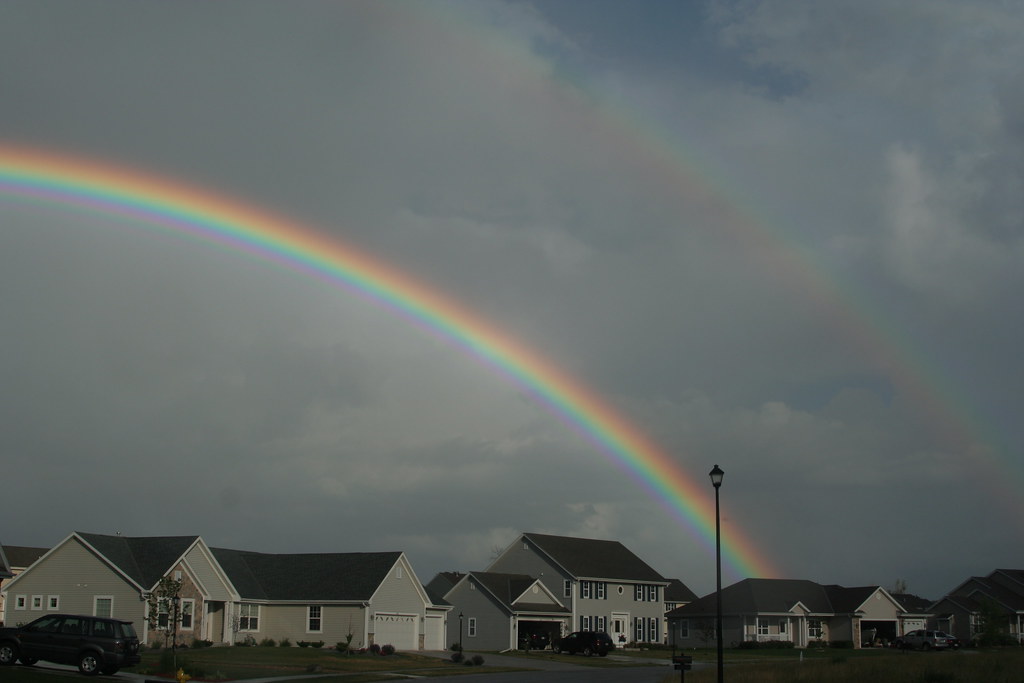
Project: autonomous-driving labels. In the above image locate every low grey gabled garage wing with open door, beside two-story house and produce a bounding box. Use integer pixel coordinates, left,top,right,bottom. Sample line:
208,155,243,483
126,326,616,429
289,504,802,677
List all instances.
431,571,570,650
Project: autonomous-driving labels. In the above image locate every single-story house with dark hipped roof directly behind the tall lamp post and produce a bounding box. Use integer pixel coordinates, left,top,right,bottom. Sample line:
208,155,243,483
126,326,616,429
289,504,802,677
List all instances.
667,579,915,647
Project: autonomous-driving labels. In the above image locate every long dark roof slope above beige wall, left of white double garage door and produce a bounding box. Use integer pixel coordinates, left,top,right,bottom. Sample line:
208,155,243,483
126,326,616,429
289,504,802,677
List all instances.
210,548,401,601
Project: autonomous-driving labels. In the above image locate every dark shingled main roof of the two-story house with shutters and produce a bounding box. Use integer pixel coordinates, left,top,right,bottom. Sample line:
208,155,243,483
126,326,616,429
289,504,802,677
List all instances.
522,533,669,584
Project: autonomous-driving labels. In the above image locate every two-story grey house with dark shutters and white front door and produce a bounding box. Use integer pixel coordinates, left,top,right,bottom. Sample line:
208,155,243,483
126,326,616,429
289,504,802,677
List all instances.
485,533,670,645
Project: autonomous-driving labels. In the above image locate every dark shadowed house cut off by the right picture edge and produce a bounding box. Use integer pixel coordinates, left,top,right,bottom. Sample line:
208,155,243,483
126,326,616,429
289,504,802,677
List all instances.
929,569,1024,643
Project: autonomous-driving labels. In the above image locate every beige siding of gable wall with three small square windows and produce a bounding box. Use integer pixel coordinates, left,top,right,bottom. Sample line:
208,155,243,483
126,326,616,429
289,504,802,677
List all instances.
4,539,145,633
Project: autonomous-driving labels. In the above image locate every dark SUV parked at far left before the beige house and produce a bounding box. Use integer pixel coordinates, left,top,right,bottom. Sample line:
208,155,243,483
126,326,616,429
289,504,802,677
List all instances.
0,614,139,676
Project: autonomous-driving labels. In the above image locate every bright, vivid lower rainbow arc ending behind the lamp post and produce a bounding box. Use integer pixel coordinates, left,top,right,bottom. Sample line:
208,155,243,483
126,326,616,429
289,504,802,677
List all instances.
0,145,777,578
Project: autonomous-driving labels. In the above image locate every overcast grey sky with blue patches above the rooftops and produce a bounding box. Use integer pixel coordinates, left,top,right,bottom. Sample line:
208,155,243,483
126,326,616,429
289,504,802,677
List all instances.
0,0,1024,598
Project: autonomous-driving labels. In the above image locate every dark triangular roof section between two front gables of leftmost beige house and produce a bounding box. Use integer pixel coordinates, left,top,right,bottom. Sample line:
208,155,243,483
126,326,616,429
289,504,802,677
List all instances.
73,531,199,590
